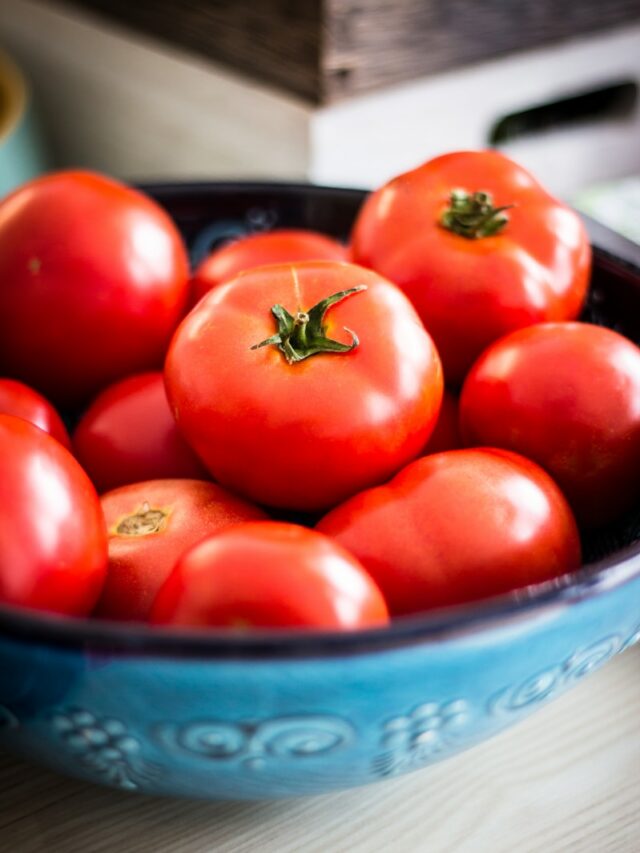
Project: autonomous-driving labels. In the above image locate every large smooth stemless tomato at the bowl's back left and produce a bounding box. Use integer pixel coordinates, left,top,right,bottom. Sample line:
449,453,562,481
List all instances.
0,172,189,405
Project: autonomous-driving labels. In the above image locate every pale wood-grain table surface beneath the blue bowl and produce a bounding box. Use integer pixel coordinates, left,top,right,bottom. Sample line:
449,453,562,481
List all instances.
0,647,640,853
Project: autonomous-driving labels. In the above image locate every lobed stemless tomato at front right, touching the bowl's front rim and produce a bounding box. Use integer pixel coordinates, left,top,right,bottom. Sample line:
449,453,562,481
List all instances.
318,449,580,614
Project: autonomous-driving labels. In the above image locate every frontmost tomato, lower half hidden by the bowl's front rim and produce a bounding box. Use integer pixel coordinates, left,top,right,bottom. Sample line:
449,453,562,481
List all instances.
151,521,389,631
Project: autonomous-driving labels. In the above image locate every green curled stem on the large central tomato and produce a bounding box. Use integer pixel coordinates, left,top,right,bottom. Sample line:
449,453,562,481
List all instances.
251,284,367,364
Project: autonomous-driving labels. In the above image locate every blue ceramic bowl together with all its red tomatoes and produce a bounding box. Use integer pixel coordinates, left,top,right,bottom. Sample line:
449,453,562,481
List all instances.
0,154,640,799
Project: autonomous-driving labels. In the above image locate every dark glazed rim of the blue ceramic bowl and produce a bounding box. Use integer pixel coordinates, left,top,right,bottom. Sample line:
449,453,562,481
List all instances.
0,180,640,659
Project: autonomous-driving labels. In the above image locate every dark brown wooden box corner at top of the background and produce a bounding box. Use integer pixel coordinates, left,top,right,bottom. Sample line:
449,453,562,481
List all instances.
52,0,640,104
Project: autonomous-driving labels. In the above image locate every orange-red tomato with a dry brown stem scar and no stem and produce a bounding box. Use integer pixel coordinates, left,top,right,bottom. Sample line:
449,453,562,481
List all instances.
95,480,266,621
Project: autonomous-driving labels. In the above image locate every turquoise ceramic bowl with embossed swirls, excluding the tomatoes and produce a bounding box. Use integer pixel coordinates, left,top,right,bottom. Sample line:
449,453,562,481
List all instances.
0,184,640,799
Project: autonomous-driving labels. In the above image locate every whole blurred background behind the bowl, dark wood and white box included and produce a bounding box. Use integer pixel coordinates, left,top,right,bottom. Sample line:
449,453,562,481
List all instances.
0,0,640,242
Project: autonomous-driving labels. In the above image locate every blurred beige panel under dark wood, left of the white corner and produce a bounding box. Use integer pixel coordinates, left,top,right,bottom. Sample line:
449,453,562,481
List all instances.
0,0,309,178
